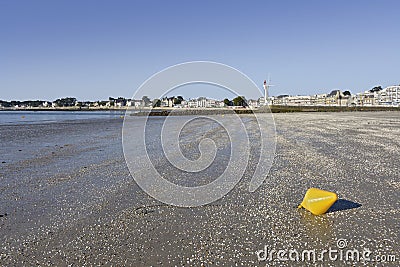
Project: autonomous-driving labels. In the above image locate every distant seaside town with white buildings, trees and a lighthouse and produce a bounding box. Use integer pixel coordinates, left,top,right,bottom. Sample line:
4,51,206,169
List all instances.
0,82,400,110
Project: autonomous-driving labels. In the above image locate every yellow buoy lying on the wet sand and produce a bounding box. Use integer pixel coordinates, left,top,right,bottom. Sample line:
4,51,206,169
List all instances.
299,188,337,215
